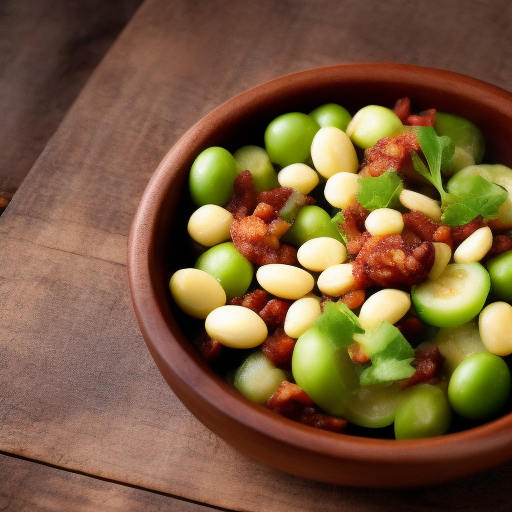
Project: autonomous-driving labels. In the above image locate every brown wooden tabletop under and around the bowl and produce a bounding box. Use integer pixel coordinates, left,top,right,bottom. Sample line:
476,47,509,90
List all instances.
0,0,512,512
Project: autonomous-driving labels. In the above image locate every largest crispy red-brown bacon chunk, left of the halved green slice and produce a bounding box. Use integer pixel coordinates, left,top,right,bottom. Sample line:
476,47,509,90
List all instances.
352,235,435,288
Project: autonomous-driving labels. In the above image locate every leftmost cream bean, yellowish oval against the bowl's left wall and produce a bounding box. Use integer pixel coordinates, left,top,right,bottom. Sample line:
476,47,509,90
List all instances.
169,268,226,319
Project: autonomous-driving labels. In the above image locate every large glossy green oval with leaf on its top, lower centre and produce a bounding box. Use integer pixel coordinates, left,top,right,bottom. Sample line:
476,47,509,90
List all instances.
292,302,362,416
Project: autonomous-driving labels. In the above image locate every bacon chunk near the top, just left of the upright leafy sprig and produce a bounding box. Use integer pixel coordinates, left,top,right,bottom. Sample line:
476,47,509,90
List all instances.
359,131,420,177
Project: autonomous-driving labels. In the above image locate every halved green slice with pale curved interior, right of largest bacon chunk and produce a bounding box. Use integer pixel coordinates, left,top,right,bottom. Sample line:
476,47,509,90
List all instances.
411,263,491,327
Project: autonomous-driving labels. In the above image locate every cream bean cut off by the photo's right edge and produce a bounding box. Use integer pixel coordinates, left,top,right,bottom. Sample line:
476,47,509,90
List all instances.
478,302,512,356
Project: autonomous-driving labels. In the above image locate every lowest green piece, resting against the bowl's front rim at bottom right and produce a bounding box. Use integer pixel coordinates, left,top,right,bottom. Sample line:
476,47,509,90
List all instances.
394,384,451,439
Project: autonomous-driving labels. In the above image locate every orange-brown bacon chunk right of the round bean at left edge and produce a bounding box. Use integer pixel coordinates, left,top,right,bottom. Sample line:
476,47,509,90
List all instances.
231,215,297,265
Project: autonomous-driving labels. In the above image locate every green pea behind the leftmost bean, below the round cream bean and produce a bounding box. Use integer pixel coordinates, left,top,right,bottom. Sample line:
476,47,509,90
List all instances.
195,242,254,300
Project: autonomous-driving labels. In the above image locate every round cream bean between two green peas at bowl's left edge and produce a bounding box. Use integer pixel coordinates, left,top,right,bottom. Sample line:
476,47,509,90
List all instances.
187,204,233,247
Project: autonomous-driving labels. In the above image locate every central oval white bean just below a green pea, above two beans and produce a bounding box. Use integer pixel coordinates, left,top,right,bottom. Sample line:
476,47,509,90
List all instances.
297,236,347,272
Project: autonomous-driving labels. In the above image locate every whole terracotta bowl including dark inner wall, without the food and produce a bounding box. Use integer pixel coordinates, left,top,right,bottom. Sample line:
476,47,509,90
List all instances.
128,64,512,487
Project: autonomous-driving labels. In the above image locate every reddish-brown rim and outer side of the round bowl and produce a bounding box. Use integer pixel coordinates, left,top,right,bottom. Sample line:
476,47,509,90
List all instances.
128,63,512,487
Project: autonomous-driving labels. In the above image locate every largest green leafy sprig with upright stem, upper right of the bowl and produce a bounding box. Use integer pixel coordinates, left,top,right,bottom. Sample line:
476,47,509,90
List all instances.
411,126,508,226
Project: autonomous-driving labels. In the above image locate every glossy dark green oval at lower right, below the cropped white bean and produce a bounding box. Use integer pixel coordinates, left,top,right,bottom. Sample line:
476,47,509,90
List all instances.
448,352,510,420
